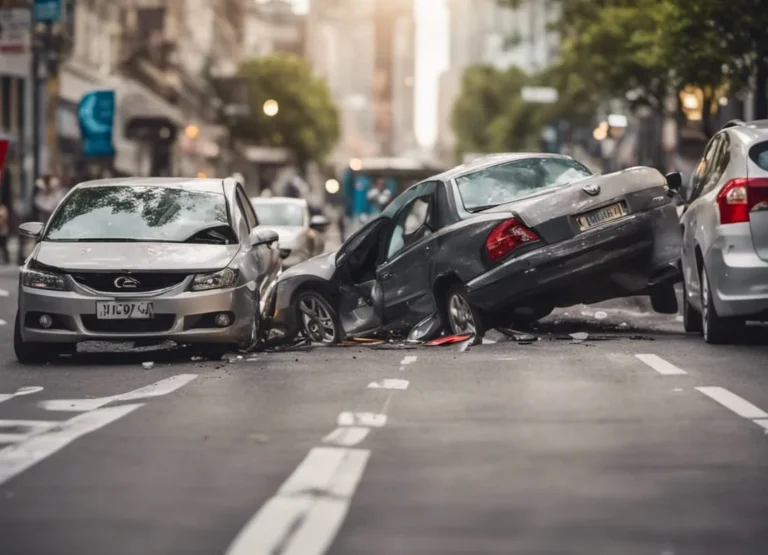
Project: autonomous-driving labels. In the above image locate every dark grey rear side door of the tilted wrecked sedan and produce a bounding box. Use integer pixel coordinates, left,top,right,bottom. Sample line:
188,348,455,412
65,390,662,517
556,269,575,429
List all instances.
376,181,437,329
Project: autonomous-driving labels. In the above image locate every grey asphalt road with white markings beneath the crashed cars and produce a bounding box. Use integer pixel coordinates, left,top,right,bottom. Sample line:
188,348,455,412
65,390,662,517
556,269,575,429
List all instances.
0,272,768,555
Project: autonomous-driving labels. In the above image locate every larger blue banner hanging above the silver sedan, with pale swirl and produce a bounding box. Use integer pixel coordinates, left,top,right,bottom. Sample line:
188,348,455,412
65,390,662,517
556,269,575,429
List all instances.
77,91,115,158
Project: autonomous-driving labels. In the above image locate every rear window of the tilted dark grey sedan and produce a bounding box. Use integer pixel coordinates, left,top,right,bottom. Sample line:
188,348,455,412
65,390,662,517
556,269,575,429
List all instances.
456,157,592,212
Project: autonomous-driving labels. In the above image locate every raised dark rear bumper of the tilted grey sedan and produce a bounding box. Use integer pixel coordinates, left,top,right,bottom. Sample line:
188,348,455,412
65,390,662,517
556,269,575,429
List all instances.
467,207,681,311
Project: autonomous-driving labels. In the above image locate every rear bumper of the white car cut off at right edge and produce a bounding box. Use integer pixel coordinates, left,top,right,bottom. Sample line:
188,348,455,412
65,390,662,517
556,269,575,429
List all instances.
704,223,768,320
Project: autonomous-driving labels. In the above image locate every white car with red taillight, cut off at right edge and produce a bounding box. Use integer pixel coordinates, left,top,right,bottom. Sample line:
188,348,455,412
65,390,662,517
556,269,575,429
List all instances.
680,120,768,343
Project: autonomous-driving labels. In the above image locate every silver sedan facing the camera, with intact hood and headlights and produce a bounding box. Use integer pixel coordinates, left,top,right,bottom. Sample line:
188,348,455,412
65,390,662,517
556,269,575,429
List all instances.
14,178,281,363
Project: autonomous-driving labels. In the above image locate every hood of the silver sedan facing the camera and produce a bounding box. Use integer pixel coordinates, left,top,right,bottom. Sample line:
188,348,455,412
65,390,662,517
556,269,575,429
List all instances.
34,241,240,272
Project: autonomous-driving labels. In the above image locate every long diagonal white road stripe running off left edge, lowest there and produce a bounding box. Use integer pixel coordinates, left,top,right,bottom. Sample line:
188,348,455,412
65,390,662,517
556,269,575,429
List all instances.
0,403,144,485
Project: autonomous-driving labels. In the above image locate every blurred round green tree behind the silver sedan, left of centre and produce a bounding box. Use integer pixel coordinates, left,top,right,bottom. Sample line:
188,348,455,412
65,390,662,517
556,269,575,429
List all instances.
225,54,339,172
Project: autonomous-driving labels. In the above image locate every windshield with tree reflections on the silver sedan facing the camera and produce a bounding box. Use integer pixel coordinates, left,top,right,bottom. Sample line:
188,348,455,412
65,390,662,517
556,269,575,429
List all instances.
45,186,231,243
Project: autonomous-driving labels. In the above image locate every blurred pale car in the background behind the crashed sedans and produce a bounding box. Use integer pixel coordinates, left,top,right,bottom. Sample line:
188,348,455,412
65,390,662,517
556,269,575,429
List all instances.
251,197,330,268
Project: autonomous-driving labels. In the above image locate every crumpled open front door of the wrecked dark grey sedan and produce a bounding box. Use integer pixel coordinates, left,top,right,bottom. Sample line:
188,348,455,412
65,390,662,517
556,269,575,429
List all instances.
336,217,392,336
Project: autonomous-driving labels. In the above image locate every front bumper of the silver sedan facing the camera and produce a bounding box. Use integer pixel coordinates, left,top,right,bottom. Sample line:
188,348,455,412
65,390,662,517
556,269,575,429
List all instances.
19,276,258,344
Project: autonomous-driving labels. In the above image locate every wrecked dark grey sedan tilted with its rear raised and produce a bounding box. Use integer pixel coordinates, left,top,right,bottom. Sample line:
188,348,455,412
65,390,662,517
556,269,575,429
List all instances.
271,154,681,342
